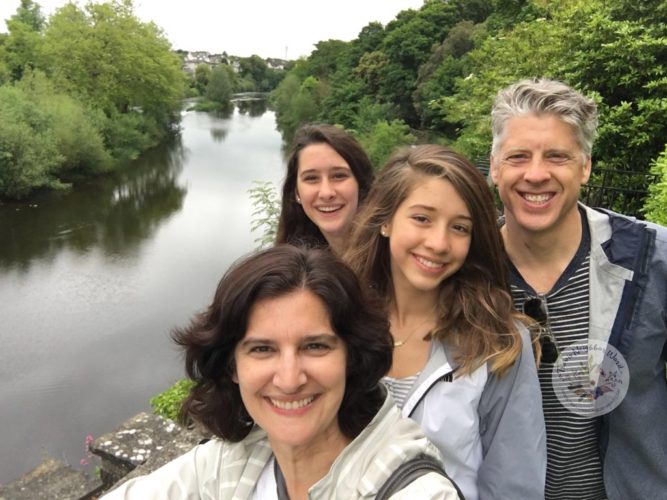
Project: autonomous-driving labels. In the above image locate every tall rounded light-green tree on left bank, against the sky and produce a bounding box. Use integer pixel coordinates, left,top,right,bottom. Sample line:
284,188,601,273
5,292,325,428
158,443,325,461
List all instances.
43,0,185,131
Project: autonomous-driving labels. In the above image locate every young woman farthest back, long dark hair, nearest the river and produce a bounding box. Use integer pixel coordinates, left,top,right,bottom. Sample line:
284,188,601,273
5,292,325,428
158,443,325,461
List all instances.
276,124,373,254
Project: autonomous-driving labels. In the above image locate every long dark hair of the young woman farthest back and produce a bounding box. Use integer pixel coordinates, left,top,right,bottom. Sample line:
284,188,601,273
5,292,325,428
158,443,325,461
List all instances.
276,124,374,247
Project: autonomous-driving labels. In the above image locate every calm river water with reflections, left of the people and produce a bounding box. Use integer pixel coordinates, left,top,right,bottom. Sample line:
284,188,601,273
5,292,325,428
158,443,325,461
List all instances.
0,99,284,483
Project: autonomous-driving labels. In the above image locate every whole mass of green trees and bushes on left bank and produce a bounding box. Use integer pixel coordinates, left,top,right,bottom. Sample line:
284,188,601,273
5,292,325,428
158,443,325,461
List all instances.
0,0,185,198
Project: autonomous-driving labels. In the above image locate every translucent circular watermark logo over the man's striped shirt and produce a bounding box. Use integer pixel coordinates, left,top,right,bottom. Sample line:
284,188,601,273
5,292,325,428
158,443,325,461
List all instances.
552,340,630,417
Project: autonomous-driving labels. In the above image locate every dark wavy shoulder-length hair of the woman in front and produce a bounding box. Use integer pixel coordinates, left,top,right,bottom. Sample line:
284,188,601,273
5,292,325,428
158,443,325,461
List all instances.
172,245,393,442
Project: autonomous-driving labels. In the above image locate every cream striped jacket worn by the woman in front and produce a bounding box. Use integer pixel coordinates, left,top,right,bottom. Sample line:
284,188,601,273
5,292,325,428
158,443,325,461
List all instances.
103,395,459,500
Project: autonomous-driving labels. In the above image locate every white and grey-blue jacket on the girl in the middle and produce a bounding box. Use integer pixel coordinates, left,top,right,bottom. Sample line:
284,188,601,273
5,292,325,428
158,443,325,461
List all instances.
403,325,546,500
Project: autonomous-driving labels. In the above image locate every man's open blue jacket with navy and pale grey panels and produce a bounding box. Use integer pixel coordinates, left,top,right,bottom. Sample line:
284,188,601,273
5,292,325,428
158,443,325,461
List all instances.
584,207,667,500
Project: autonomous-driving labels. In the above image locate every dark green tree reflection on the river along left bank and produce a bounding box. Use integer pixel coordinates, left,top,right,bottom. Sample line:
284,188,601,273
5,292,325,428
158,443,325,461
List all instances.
0,138,187,271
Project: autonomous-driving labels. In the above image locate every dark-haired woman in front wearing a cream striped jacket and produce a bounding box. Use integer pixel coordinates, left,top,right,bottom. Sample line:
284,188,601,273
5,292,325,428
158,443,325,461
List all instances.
102,245,458,500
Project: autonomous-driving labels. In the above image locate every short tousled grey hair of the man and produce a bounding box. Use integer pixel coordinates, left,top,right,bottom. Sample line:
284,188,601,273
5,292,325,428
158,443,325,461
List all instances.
491,79,598,157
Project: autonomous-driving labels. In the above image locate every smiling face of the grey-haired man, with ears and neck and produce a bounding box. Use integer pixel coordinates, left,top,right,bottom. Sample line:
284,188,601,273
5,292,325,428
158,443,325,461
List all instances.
491,114,591,234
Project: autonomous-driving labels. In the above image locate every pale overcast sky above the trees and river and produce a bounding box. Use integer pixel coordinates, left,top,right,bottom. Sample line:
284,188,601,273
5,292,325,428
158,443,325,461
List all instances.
0,0,423,59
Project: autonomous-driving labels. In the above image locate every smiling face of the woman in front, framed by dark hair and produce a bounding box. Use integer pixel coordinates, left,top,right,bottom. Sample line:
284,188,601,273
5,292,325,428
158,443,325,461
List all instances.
234,289,349,458
